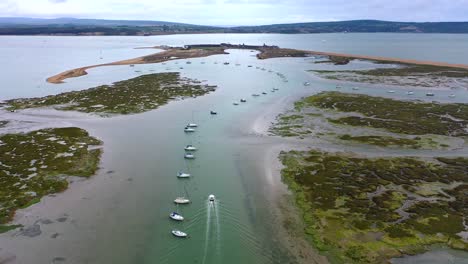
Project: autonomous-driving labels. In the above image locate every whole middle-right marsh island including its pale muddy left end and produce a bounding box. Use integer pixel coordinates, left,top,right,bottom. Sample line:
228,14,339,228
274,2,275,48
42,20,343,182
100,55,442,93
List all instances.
270,92,468,149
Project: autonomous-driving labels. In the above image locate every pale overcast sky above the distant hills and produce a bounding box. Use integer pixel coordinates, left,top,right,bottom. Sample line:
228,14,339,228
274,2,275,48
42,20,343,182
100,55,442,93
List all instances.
0,0,468,26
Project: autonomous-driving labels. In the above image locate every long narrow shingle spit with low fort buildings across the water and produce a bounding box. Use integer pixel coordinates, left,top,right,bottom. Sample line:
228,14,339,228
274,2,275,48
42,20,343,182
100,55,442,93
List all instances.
46,44,468,84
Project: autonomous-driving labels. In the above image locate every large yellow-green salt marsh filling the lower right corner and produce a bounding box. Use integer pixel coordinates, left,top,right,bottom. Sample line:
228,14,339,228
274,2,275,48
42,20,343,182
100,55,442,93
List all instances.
280,151,468,263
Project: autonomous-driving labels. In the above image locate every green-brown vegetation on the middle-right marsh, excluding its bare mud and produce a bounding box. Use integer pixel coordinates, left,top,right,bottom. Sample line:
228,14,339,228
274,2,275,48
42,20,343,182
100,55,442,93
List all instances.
308,92,468,136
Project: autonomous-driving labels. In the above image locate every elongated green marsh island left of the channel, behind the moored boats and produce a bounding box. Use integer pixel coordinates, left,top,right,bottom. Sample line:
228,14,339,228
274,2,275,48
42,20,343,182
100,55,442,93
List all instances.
7,72,215,115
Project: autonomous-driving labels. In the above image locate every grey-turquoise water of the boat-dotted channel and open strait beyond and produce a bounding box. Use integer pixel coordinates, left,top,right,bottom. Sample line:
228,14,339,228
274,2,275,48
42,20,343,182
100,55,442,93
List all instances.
0,34,468,263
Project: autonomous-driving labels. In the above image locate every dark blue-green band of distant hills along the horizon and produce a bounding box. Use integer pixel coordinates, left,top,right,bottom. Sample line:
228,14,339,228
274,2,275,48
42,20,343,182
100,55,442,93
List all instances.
0,17,468,35
